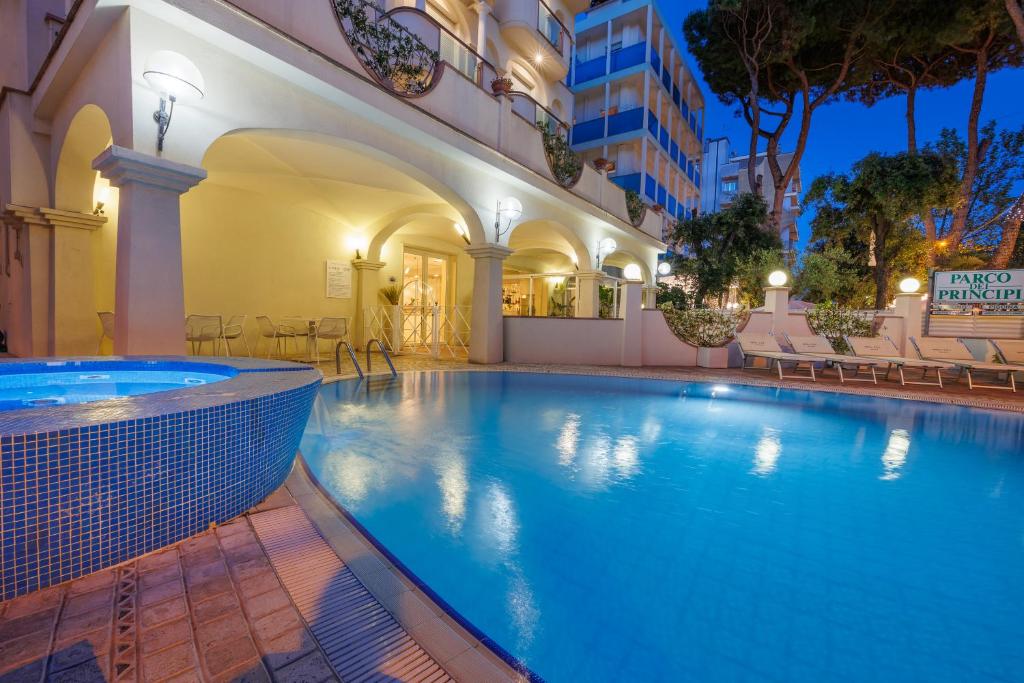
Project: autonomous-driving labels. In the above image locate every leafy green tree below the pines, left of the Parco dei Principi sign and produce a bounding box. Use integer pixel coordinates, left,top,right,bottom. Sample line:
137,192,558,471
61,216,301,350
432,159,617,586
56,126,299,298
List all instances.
806,153,956,309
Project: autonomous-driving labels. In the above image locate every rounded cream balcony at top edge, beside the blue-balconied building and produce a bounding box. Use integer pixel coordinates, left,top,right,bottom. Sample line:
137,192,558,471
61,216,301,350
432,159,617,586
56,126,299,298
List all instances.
495,0,572,81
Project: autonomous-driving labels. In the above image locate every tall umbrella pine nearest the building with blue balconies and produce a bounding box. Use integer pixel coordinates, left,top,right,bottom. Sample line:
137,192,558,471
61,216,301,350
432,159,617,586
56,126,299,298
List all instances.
683,0,882,238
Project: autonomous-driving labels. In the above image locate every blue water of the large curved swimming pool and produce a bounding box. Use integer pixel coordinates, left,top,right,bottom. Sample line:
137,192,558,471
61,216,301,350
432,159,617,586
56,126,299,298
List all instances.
301,373,1024,682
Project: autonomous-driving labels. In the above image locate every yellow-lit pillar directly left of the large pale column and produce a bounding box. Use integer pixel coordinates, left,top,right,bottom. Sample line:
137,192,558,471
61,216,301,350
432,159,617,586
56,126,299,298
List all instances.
39,209,106,355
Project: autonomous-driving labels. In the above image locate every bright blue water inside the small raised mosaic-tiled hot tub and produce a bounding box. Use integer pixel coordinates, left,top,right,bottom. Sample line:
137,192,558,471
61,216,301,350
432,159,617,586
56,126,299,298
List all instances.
0,366,234,411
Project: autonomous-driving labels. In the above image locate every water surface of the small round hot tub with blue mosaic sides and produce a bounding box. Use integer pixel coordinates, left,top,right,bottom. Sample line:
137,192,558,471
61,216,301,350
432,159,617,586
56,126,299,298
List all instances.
0,360,237,411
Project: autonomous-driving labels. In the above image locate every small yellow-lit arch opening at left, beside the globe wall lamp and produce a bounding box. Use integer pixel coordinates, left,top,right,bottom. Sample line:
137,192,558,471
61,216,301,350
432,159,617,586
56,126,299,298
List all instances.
53,104,113,213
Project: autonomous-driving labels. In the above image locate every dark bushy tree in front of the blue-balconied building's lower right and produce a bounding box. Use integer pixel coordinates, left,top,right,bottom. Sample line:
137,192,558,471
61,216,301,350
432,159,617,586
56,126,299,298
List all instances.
671,193,782,307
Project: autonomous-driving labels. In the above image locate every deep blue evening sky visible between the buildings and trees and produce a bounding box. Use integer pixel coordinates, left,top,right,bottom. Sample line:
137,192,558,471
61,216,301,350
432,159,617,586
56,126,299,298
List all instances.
659,0,1024,248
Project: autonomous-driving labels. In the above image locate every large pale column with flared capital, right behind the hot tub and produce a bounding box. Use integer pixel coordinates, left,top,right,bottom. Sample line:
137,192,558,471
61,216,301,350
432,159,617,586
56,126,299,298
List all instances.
92,145,206,355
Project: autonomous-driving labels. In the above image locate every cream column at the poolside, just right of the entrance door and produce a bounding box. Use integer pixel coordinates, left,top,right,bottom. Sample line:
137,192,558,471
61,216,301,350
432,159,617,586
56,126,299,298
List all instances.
466,244,512,364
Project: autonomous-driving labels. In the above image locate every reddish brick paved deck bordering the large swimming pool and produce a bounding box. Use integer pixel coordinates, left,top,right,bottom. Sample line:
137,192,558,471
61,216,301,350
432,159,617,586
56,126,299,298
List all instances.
0,355,1024,683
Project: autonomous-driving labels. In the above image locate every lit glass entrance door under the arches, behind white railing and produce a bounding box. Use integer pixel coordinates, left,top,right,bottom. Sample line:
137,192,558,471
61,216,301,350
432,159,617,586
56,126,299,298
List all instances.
401,249,450,347
